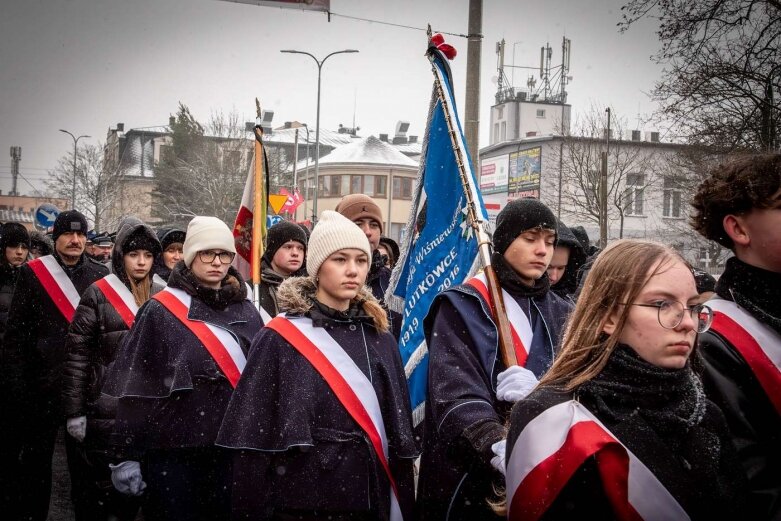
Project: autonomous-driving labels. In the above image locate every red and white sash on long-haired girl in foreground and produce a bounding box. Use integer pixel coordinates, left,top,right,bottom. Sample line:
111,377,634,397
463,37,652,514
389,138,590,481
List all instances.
506,400,689,521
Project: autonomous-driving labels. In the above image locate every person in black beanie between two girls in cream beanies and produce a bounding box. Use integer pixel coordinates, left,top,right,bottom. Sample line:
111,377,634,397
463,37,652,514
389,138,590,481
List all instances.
260,221,307,323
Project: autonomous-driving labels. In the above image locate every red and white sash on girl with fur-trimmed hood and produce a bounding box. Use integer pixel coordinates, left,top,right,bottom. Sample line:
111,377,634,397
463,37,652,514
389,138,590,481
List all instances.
266,314,402,521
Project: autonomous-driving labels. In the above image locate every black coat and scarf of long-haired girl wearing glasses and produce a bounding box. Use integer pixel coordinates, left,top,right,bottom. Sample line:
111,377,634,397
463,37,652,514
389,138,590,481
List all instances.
506,345,749,519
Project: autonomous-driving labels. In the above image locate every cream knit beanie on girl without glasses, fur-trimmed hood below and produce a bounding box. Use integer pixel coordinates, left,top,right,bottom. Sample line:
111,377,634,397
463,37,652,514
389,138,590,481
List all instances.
308,210,372,277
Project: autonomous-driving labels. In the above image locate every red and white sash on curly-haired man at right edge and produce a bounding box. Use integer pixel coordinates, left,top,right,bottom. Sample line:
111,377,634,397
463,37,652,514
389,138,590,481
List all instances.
707,298,781,415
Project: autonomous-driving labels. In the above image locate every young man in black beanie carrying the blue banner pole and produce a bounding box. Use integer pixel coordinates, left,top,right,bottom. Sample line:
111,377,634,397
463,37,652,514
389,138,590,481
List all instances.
417,199,571,520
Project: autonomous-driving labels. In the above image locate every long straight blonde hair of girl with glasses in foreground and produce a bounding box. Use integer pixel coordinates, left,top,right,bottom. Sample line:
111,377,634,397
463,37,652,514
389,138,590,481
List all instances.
540,239,689,391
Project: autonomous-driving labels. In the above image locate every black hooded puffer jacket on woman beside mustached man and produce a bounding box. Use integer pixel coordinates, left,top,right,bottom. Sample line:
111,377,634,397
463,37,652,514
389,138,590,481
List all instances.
62,220,163,447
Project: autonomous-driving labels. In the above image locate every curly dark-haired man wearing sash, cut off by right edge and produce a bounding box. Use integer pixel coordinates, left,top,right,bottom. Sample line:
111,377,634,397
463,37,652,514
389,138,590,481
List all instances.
692,153,781,519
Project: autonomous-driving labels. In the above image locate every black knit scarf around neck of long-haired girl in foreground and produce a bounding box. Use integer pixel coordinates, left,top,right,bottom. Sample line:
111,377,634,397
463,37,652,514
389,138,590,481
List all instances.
577,344,706,438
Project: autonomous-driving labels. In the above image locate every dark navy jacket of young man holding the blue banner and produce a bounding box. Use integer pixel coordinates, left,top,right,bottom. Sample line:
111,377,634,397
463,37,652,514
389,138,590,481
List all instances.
418,254,572,520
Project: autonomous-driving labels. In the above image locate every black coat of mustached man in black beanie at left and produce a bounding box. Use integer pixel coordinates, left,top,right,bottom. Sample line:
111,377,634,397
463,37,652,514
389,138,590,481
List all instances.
4,250,108,415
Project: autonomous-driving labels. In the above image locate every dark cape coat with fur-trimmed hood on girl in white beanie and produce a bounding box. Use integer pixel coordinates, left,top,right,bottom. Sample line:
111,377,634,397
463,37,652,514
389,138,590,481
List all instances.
217,277,418,520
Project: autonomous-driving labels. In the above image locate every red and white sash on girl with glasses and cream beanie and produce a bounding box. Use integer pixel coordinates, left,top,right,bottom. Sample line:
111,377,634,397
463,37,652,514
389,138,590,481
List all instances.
152,287,247,389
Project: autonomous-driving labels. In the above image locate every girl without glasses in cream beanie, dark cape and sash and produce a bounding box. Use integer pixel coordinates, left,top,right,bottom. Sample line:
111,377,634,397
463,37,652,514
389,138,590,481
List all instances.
217,211,417,519
